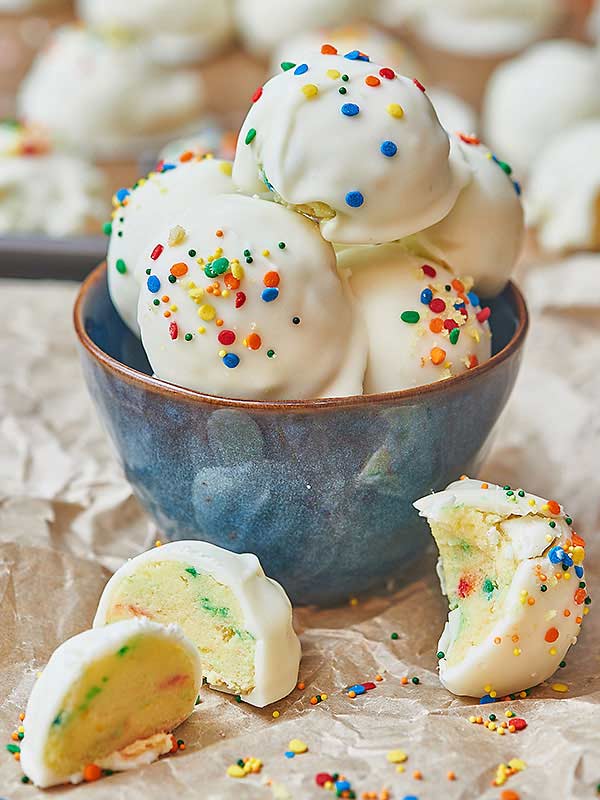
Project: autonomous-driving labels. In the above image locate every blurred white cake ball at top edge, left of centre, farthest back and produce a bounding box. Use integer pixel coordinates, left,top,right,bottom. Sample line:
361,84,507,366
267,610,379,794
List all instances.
77,0,234,64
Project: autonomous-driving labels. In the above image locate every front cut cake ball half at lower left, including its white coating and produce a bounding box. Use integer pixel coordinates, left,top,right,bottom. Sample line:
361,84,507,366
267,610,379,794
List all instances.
21,619,202,788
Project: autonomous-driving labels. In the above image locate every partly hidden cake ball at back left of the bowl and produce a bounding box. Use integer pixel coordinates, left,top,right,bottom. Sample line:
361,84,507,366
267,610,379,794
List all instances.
106,155,233,335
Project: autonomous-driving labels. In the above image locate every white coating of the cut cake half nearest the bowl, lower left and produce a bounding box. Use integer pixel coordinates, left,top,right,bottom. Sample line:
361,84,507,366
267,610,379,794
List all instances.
94,541,301,708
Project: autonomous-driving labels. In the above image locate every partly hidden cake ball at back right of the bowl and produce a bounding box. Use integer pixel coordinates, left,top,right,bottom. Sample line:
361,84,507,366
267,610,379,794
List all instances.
414,134,524,297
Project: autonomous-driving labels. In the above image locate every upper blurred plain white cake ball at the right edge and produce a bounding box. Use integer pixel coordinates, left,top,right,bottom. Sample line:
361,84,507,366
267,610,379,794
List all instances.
483,40,600,174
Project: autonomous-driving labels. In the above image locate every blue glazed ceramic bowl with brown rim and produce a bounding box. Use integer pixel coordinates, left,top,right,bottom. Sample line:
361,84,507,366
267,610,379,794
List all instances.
75,265,528,605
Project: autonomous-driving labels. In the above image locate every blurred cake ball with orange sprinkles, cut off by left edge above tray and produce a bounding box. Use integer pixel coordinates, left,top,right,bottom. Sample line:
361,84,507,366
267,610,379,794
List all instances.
0,122,110,237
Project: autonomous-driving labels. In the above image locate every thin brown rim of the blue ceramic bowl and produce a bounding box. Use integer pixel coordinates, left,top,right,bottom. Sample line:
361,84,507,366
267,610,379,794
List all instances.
73,261,529,411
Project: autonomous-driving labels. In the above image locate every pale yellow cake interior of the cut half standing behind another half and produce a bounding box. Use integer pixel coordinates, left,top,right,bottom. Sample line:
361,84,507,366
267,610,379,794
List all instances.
106,561,256,695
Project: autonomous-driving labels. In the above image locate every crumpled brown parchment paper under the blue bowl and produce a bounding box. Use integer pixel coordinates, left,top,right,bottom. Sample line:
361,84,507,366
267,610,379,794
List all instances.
0,255,600,800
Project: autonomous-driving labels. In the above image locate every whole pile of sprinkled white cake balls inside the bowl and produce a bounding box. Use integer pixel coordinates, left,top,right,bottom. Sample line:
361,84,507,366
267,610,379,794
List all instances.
106,45,523,400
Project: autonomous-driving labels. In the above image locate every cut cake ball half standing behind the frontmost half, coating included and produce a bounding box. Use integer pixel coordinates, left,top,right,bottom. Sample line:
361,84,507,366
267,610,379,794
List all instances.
94,541,300,708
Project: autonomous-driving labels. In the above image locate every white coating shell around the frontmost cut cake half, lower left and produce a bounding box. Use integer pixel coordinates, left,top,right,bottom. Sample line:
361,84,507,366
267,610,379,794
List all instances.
21,619,202,788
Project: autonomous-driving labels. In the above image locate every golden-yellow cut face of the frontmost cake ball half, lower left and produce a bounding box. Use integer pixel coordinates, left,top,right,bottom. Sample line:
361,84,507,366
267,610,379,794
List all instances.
44,634,197,775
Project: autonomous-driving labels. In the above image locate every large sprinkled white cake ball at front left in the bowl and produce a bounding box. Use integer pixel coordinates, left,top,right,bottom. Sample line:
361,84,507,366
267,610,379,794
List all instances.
138,195,366,400
